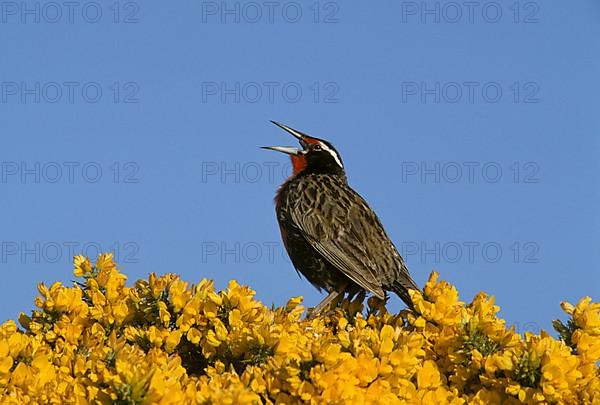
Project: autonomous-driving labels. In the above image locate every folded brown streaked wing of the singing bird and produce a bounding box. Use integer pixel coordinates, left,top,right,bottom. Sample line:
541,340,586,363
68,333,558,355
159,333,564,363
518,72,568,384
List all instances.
291,180,395,299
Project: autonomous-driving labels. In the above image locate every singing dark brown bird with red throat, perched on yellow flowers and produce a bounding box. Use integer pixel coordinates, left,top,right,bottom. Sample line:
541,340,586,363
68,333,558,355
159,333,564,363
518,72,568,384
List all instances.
262,121,419,316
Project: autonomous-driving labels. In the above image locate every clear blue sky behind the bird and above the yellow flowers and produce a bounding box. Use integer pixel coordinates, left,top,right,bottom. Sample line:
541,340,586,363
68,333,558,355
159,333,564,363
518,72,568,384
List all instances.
0,0,600,331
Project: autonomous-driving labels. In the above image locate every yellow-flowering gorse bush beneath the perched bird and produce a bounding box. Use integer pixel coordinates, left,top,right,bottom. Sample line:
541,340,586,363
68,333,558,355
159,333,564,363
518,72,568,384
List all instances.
0,255,600,405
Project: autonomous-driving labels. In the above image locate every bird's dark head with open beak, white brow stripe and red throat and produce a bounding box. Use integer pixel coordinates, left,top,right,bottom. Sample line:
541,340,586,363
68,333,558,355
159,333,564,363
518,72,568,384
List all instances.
263,121,345,176
